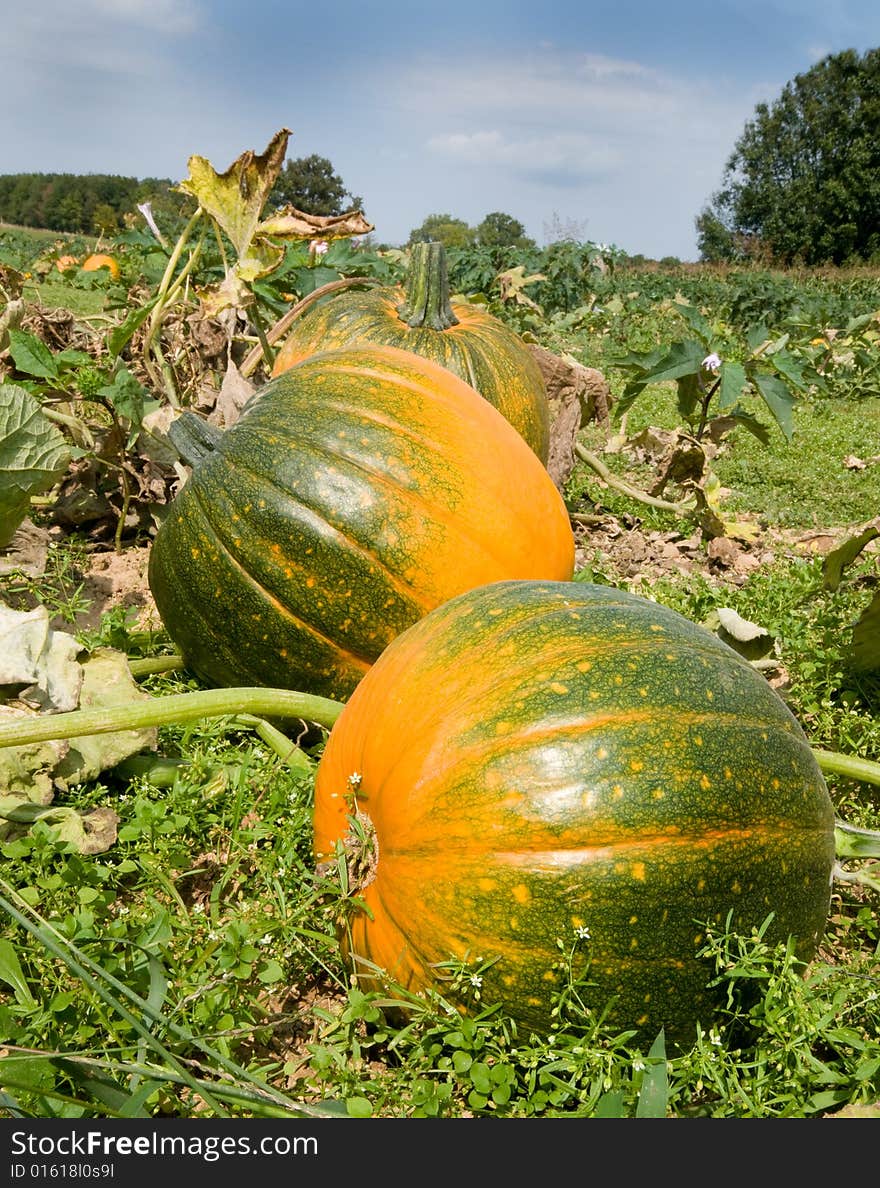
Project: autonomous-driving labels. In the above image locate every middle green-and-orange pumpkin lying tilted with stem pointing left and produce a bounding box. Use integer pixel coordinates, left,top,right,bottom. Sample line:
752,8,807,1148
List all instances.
148,346,575,699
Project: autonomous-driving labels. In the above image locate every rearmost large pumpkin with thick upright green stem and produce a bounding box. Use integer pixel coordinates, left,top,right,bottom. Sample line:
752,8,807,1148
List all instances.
272,242,550,465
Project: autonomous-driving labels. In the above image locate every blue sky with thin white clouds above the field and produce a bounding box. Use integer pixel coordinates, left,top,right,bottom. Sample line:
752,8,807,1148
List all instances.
0,0,880,260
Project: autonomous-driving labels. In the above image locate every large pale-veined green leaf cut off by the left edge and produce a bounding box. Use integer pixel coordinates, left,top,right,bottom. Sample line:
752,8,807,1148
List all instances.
0,384,71,549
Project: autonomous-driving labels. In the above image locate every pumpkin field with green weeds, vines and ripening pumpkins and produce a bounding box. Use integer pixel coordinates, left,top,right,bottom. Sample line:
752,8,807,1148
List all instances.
0,133,880,1119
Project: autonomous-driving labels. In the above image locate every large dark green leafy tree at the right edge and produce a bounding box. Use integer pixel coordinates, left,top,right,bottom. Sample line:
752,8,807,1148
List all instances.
696,50,880,264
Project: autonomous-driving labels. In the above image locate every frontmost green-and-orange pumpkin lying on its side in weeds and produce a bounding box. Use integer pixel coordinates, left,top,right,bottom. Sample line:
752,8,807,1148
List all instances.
314,581,835,1043
